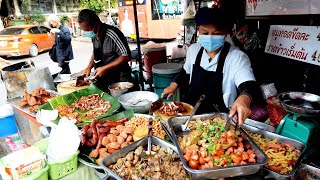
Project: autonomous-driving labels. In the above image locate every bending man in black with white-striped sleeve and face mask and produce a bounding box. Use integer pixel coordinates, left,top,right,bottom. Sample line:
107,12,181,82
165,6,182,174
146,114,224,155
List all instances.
78,9,131,92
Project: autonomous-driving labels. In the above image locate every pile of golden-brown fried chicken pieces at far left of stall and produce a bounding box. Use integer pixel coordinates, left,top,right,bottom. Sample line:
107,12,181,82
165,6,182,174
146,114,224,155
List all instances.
19,88,55,112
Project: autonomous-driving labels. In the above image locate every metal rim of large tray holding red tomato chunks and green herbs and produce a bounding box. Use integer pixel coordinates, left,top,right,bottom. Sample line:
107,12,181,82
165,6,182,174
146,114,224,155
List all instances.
168,113,268,179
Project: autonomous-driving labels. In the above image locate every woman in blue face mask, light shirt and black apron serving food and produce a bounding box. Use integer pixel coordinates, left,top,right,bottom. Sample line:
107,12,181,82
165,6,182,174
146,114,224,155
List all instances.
162,8,259,125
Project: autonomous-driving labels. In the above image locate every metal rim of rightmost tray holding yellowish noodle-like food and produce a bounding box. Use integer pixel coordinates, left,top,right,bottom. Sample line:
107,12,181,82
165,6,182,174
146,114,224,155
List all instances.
242,124,306,180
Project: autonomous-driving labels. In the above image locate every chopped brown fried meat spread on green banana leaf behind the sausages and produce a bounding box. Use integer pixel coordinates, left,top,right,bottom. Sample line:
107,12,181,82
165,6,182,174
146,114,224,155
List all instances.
56,94,111,123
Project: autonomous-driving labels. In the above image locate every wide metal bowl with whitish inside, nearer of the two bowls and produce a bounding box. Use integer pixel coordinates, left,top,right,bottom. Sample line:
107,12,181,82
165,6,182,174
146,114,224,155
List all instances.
119,91,159,114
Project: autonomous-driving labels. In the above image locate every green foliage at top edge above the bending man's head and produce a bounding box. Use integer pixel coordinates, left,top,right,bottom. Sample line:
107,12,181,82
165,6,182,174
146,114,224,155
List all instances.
80,0,118,13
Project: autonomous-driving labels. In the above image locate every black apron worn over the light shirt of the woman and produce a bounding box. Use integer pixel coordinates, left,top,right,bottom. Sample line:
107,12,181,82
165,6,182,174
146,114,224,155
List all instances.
187,42,230,114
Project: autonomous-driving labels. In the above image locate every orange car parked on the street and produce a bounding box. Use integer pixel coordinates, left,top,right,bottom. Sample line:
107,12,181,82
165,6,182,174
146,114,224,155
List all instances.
0,25,54,57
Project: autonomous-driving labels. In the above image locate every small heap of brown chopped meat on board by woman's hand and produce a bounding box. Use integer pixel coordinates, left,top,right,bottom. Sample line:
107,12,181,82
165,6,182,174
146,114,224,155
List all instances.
159,101,186,116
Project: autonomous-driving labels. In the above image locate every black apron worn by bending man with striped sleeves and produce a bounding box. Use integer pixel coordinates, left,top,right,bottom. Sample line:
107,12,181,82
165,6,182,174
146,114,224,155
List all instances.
93,24,131,92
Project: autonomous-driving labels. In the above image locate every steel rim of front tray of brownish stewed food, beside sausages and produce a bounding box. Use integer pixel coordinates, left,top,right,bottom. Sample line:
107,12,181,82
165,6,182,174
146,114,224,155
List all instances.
100,136,178,180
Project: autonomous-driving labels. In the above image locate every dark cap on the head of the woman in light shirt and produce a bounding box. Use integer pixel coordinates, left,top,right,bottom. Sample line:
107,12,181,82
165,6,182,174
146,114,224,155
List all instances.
195,7,233,31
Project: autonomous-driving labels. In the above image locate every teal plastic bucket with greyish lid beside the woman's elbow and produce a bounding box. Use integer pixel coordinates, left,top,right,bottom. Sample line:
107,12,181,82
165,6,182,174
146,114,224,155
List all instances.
152,63,182,101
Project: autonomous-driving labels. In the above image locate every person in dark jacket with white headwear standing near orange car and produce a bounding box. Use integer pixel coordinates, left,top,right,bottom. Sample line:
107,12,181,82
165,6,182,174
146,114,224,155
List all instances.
48,14,73,74
